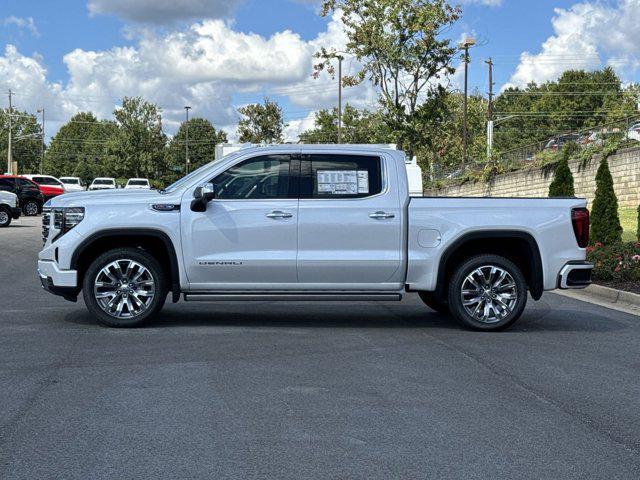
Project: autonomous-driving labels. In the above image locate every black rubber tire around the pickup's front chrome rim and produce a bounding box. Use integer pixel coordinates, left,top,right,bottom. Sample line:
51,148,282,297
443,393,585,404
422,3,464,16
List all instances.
82,248,168,327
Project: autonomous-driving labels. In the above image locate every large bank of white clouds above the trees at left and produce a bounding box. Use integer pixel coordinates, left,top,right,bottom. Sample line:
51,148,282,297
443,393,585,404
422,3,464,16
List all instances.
0,10,376,140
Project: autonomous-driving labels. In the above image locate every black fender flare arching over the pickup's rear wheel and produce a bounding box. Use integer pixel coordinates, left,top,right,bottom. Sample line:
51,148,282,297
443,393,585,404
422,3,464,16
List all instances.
436,230,544,300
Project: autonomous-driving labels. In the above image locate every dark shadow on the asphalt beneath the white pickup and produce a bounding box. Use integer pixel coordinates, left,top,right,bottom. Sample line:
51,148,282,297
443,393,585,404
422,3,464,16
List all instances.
64,302,629,335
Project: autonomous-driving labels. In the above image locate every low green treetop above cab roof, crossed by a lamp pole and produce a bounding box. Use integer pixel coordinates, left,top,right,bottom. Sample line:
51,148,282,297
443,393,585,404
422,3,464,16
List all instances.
300,104,393,143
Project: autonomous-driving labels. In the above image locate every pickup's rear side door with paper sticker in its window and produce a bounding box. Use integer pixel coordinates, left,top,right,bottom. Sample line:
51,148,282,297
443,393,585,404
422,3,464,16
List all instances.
298,153,404,290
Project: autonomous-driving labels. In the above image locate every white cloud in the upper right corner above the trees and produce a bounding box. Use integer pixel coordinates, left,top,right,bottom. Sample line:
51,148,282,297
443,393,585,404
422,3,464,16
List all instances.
510,0,640,86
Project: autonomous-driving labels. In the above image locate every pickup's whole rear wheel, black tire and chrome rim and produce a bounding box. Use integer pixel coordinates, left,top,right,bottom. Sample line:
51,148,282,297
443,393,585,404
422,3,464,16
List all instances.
449,255,527,331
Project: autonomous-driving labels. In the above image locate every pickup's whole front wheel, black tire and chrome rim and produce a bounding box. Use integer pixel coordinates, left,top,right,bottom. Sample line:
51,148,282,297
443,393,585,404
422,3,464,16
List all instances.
82,248,167,327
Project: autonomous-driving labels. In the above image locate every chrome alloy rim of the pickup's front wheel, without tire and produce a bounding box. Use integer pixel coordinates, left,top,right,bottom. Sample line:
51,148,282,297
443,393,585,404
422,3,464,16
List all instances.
93,258,156,318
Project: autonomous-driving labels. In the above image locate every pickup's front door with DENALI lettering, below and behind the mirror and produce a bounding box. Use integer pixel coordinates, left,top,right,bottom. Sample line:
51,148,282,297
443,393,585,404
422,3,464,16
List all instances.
181,155,300,290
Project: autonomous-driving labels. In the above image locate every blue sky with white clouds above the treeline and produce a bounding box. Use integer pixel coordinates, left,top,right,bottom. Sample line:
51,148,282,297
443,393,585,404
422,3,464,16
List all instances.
0,0,640,141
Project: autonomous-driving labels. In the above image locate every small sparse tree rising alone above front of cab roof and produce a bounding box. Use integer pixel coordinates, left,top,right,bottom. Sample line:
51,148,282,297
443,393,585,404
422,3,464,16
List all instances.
238,98,285,143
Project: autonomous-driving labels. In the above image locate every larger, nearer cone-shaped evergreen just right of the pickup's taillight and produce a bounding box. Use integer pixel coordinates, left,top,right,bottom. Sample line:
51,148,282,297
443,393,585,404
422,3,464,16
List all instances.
591,155,622,245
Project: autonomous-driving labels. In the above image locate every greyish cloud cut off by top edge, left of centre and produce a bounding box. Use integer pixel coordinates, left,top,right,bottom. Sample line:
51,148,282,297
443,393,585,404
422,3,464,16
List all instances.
87,0,240,24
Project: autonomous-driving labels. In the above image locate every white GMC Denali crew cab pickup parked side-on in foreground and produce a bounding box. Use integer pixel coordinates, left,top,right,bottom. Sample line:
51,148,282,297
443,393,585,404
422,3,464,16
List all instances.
38,145,592,330
